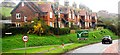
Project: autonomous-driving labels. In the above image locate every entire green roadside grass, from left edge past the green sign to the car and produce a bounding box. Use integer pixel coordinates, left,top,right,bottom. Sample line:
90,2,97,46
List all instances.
2,29,118,53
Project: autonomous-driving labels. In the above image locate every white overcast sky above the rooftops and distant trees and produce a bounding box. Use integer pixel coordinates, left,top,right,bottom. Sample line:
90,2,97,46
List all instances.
0,0,120,13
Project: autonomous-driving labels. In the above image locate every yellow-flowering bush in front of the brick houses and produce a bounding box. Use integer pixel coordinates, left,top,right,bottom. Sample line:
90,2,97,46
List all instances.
28,18,49,35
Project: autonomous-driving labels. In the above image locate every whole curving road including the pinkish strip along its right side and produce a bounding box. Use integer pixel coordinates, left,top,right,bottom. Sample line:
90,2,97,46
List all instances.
63,40,118,55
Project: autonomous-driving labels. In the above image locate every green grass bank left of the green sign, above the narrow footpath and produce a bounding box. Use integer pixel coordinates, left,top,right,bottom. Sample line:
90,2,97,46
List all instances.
2,34,77,52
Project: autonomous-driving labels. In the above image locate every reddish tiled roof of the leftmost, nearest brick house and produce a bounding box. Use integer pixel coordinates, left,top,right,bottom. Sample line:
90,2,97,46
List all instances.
11,2,51,13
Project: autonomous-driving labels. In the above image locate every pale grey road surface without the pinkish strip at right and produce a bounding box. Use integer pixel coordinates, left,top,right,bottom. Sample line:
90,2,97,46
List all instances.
67,40,118,53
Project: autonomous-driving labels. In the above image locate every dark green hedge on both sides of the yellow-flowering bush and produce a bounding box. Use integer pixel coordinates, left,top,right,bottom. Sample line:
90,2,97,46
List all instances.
2,26,70,37
